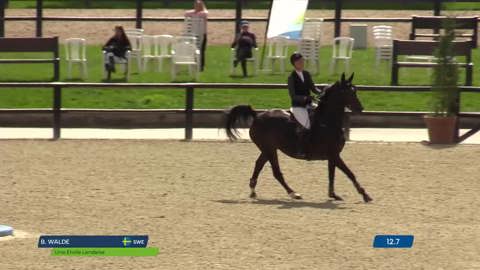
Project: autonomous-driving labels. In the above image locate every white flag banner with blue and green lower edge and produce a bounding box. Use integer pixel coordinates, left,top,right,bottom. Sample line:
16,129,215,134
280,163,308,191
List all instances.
267,0,308,39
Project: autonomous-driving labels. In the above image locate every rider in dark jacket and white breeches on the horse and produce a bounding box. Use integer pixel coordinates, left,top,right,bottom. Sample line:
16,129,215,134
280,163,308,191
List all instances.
288,53,318,157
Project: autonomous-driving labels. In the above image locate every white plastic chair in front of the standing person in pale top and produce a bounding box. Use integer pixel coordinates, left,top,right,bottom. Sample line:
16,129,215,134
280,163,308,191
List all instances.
171,37,200,80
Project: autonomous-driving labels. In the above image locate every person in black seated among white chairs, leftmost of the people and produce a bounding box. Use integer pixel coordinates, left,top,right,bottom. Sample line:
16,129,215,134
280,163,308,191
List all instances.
103,26,131,78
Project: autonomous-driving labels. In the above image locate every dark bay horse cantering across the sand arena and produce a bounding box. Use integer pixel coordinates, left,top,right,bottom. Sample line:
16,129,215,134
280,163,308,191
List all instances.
225,74,372,202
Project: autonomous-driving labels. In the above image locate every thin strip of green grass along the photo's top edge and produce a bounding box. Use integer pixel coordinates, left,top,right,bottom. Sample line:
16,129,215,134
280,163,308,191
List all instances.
9,0,480,10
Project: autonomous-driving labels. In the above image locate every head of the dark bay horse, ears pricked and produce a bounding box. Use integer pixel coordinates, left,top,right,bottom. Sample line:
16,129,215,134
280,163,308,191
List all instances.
322,73,363,113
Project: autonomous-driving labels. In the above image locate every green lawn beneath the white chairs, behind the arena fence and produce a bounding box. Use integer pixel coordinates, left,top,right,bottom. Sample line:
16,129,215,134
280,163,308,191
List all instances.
0,46,480,111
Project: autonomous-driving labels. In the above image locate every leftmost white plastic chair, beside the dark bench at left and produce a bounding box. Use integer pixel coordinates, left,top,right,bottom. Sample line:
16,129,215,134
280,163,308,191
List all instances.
65,38,88,79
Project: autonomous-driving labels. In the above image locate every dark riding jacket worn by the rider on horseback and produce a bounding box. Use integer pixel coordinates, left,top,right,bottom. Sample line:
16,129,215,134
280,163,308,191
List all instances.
288,70,318,107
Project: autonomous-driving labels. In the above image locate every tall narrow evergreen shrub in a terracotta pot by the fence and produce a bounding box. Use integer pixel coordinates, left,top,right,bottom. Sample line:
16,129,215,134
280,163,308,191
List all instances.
424,19,459,144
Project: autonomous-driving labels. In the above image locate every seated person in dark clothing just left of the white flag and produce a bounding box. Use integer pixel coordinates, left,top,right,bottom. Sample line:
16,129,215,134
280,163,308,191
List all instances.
232,21,257,77
